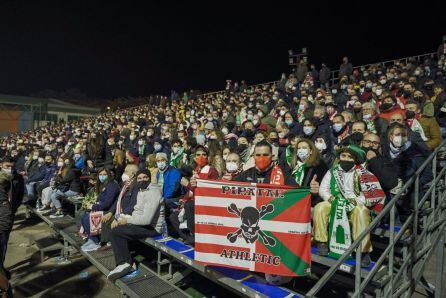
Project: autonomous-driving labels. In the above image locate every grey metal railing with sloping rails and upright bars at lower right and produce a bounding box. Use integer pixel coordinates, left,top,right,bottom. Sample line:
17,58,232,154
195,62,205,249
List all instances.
306,140,446,298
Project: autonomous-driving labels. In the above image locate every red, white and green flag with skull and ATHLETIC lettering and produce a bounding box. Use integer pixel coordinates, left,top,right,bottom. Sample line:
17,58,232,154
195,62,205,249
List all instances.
195,180,311,276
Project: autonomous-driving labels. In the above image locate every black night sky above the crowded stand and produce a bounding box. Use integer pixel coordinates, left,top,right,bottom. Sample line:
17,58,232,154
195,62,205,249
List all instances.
0,0,446,98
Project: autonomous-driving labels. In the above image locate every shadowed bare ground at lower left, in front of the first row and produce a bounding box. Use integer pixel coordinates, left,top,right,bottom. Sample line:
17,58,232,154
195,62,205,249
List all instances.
5,210,119,298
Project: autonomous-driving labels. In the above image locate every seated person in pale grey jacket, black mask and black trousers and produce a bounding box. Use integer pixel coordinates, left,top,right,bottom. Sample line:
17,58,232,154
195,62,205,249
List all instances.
107,171,165,281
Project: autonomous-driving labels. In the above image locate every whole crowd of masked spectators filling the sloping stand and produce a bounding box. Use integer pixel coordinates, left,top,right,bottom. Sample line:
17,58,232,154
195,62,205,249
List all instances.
0,42,446,279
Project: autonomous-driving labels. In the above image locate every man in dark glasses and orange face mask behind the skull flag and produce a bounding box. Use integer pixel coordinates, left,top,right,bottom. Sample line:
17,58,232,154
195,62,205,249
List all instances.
234,140,296,185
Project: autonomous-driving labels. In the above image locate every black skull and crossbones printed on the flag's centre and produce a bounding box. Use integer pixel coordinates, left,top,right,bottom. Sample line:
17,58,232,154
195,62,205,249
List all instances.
226,203,276,246
